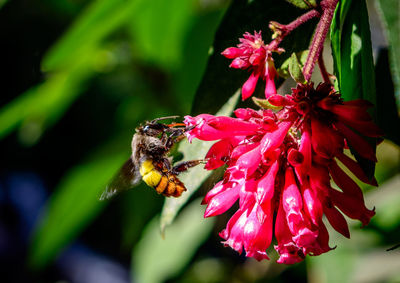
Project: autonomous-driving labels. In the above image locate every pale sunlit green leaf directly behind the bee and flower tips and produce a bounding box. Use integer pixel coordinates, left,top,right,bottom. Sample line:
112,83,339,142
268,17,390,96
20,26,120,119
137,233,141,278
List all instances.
160,91,240,232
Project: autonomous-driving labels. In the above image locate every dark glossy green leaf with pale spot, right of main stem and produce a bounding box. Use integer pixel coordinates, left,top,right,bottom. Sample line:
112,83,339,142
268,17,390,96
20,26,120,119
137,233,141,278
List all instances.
331,0,376,178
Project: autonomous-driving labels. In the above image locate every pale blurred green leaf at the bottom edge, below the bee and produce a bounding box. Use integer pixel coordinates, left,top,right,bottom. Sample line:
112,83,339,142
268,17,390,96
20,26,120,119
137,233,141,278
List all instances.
132,199,214,283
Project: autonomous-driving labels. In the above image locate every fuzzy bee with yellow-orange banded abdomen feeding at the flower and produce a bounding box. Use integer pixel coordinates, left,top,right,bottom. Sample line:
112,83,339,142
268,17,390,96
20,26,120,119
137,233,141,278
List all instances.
100,116,203,200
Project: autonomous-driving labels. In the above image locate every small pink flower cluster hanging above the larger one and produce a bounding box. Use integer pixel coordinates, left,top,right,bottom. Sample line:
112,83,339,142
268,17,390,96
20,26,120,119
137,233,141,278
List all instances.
222,31,282,100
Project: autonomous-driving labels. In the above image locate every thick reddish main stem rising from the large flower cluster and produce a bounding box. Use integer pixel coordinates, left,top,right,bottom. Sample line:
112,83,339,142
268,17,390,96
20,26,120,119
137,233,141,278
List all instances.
303,0,339,81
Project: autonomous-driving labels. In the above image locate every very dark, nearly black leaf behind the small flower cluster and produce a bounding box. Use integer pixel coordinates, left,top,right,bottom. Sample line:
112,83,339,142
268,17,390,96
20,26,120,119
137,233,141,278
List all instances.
192,0,315,115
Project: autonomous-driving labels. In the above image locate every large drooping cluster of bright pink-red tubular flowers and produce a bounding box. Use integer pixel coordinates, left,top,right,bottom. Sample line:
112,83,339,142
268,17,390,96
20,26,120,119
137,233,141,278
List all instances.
185,82,382,264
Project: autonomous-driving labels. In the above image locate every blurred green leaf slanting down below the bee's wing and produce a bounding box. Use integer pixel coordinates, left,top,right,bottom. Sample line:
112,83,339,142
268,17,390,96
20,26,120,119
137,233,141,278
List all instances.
29,152,126,269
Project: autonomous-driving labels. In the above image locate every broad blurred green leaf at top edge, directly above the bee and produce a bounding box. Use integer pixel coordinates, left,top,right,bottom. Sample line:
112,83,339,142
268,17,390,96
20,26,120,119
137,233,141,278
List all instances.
130,0,195,70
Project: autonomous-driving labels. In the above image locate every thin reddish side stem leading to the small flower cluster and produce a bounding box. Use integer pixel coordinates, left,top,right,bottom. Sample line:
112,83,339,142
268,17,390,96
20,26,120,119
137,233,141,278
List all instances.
268,9,321,50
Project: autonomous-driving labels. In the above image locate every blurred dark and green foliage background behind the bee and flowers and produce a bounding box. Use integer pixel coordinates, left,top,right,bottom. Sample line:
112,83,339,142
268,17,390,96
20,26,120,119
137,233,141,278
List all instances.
0,0,400,283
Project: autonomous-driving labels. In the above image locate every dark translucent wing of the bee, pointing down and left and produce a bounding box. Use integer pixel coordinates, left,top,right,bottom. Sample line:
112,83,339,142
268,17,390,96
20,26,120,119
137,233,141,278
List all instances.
99,158,141,200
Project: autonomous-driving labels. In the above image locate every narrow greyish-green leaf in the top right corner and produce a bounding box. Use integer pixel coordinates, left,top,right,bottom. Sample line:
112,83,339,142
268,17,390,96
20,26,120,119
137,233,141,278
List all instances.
375,0,400,103
